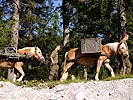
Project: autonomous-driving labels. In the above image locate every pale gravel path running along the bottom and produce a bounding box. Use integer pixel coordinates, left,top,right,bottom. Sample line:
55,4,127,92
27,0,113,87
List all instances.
0,78,133,100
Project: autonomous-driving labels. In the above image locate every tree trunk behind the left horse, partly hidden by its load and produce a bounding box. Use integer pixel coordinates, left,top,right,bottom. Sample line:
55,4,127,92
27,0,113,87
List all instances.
7,0,19,81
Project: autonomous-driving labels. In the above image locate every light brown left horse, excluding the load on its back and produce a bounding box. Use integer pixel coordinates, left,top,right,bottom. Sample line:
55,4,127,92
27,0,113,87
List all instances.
0,47,45,81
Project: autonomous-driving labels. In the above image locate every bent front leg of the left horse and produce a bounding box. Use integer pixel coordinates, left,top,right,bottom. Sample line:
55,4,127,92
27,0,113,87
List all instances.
15,62,25,82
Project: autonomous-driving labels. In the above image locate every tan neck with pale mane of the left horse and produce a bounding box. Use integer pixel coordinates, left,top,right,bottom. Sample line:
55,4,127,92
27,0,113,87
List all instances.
18,47,35,57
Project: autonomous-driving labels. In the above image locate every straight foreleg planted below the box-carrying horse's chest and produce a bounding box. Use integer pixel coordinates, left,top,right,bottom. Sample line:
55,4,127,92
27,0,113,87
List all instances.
95,56,104,81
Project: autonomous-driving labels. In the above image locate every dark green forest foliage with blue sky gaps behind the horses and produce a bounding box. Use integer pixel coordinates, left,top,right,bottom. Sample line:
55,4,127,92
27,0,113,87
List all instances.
0,0,133,80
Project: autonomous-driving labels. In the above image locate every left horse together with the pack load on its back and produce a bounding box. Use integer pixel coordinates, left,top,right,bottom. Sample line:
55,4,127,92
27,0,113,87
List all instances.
0,47,45,81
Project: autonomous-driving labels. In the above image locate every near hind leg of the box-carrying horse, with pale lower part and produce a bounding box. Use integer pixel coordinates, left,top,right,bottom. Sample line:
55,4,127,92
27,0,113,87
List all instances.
60,62,74,81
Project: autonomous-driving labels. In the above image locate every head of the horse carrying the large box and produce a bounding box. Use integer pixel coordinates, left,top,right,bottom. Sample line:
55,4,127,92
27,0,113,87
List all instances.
117,42,129,58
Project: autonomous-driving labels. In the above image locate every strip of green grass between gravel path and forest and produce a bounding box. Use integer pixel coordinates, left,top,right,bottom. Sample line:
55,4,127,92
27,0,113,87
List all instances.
0,74,133,88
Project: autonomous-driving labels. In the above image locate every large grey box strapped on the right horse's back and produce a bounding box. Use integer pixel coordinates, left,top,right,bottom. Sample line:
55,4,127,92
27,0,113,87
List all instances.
81,38,101,54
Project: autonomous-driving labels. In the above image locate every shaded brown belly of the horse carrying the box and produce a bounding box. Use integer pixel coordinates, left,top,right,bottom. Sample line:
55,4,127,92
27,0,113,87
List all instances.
78,57,97,66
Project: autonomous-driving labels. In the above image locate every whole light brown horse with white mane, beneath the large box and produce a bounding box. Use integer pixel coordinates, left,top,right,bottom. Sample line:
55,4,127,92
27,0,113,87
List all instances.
60,42,129,81
